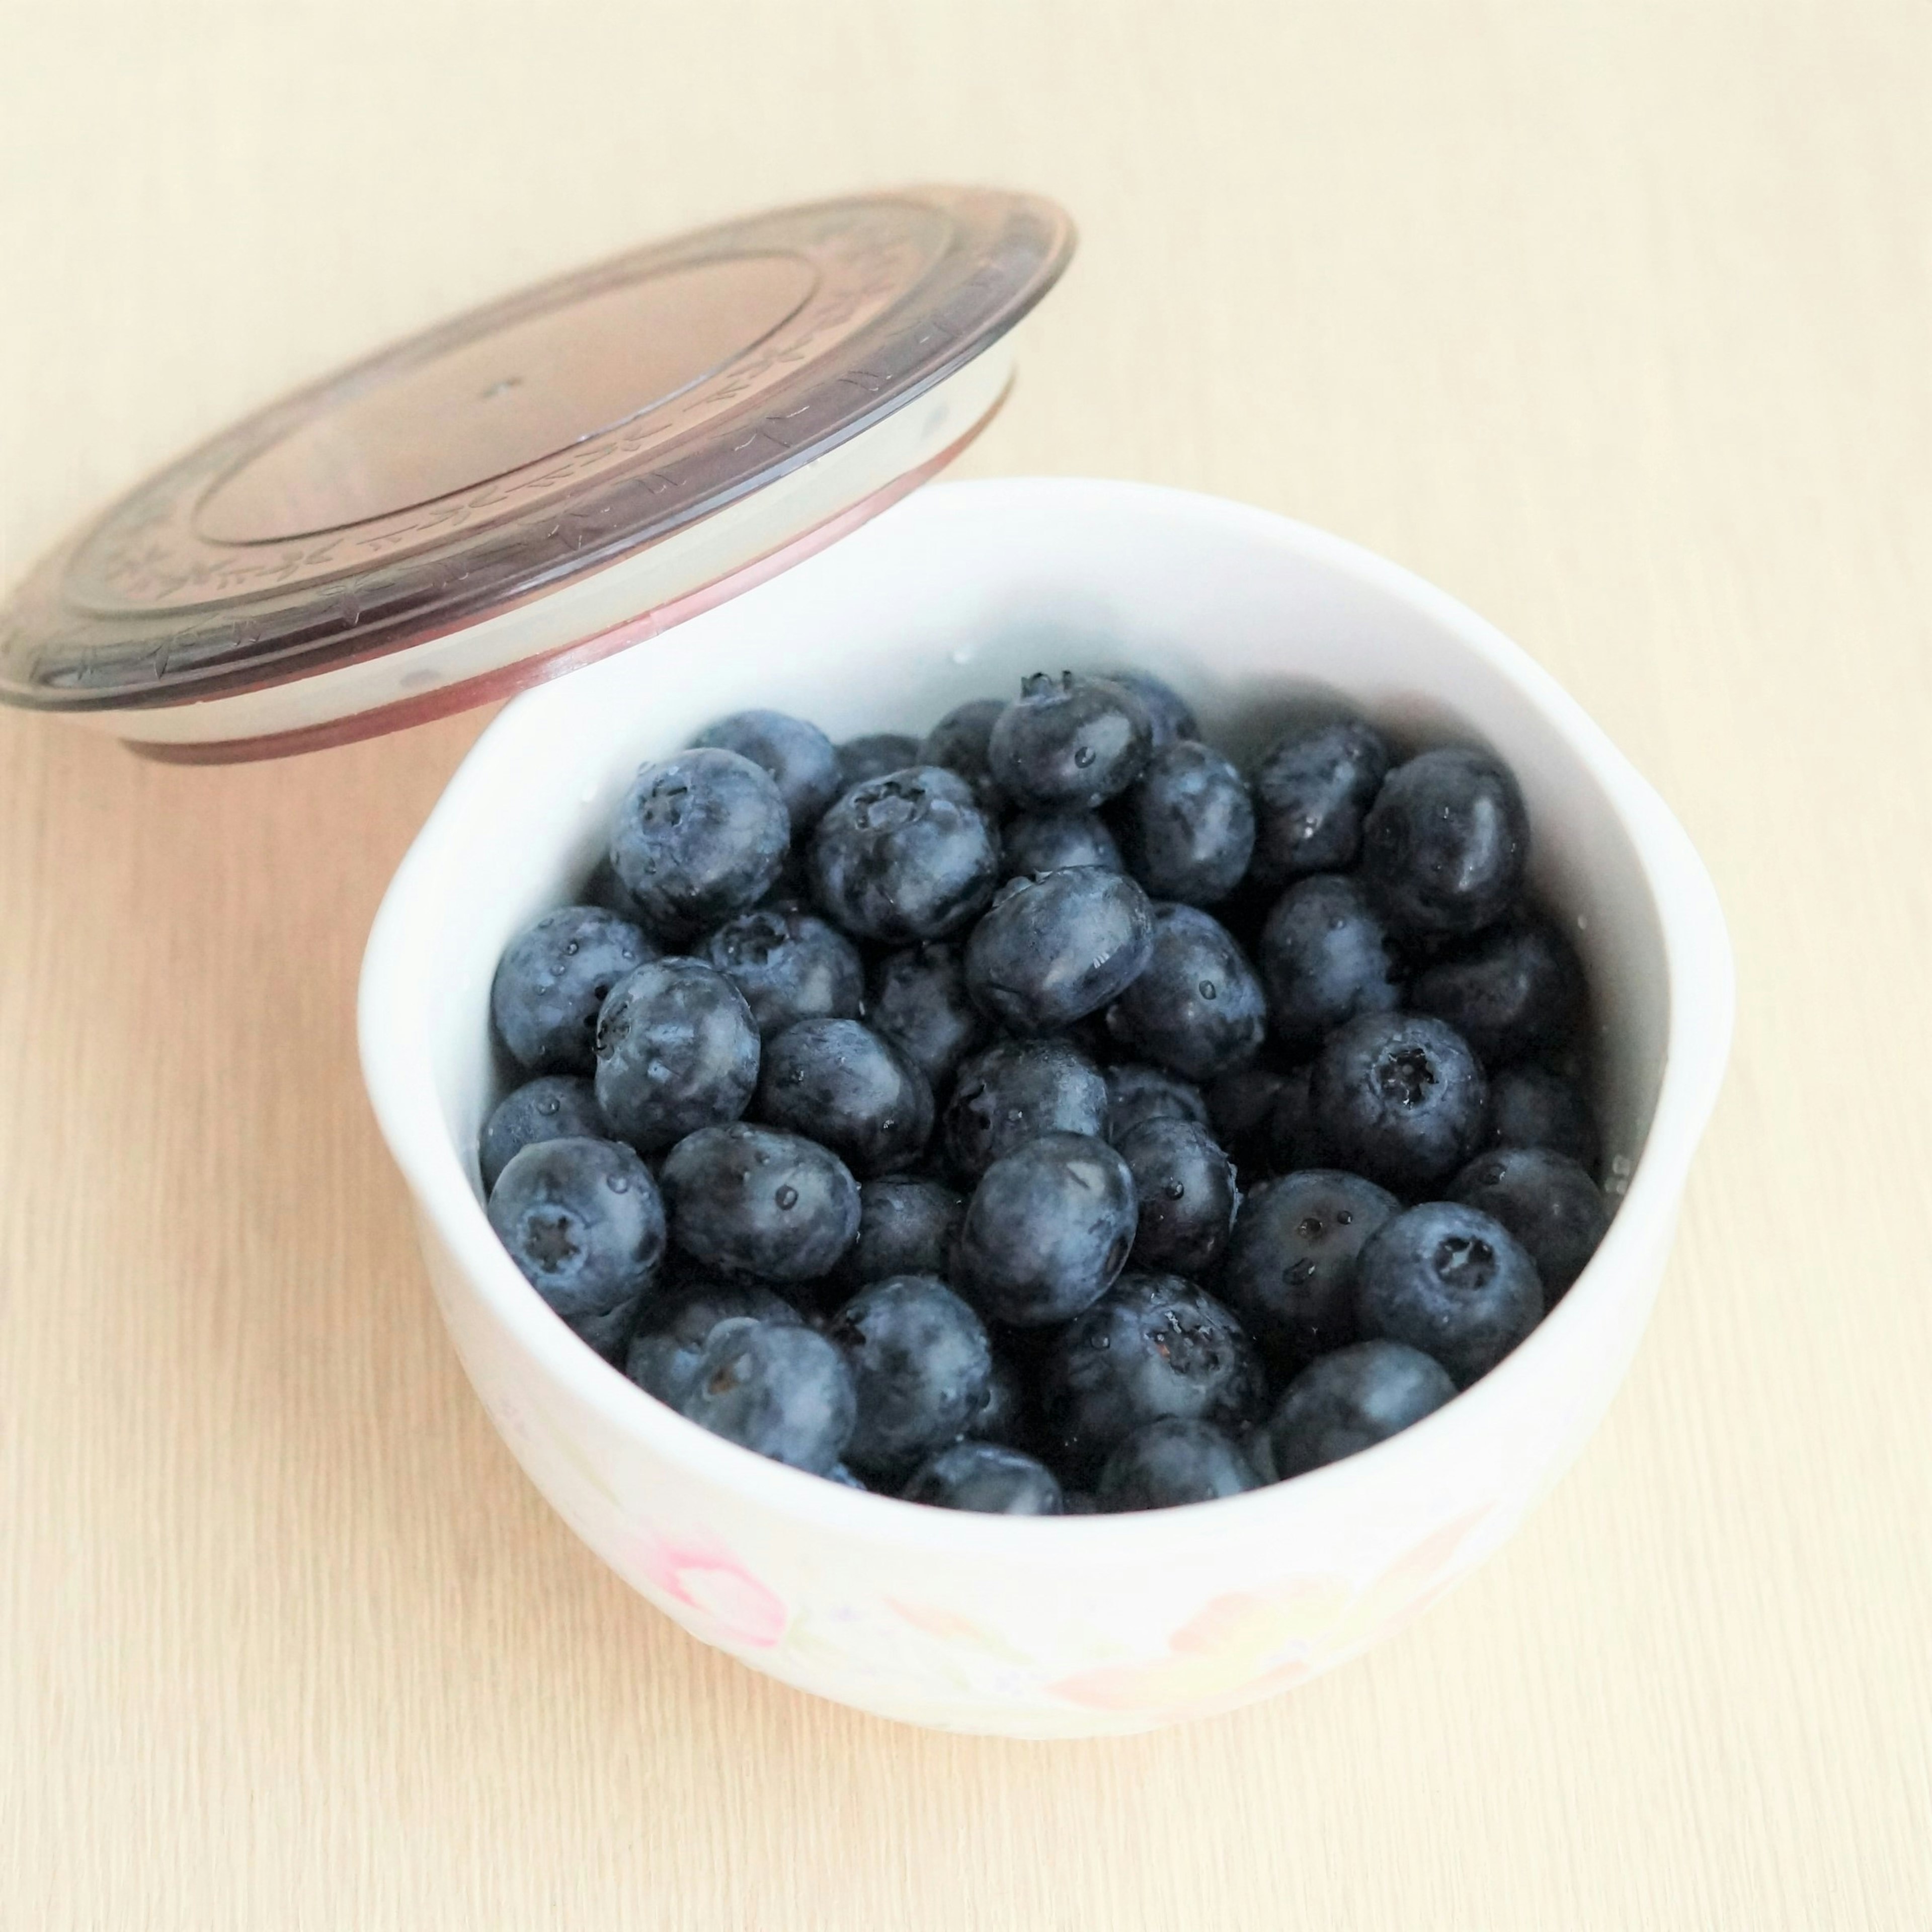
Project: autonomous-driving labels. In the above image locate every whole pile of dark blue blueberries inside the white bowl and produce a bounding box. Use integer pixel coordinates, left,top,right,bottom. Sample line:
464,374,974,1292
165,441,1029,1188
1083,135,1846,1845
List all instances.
479,672,1609,1515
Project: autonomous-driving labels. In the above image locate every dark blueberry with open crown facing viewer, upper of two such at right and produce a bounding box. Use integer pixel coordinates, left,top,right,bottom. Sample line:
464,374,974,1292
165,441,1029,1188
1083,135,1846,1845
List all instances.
1308,1012,1488,1196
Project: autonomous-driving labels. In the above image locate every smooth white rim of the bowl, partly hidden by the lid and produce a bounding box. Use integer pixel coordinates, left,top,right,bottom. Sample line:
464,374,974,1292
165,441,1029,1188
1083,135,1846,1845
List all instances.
357,477,1735,1567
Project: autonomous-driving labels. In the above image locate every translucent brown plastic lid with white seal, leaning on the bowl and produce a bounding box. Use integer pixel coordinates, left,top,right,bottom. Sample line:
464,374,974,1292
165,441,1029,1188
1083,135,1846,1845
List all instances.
0,187,1074,761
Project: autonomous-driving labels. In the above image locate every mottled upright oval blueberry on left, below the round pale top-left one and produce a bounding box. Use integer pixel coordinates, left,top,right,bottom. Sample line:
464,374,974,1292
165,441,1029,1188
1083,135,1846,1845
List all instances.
597,958,757,1153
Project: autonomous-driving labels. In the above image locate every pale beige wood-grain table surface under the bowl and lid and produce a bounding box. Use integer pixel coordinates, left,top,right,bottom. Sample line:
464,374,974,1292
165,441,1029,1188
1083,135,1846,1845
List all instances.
0,0,1932,1932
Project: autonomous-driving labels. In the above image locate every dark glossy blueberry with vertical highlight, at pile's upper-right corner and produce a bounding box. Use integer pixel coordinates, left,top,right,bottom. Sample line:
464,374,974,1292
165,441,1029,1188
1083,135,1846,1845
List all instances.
1362,746,1530,939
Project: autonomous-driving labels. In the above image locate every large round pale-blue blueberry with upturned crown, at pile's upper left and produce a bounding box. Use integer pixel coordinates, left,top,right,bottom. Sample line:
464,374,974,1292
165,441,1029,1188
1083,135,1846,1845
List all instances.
610,746,792,935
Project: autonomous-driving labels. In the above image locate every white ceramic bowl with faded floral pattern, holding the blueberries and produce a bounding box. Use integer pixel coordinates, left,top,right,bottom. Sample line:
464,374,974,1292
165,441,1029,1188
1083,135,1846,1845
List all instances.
361,481,1731,1737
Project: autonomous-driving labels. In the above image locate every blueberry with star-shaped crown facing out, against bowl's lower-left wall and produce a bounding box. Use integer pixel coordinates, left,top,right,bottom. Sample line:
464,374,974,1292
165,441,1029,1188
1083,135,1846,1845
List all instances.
489,1140,665,1356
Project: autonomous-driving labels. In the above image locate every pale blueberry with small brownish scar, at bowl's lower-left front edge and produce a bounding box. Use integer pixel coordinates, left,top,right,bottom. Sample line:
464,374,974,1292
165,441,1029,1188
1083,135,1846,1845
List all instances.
678,1322,858,1476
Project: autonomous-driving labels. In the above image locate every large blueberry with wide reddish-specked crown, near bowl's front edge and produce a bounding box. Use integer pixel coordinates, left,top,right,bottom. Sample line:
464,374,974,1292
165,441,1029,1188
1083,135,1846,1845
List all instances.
1039,1273,1267,1478
